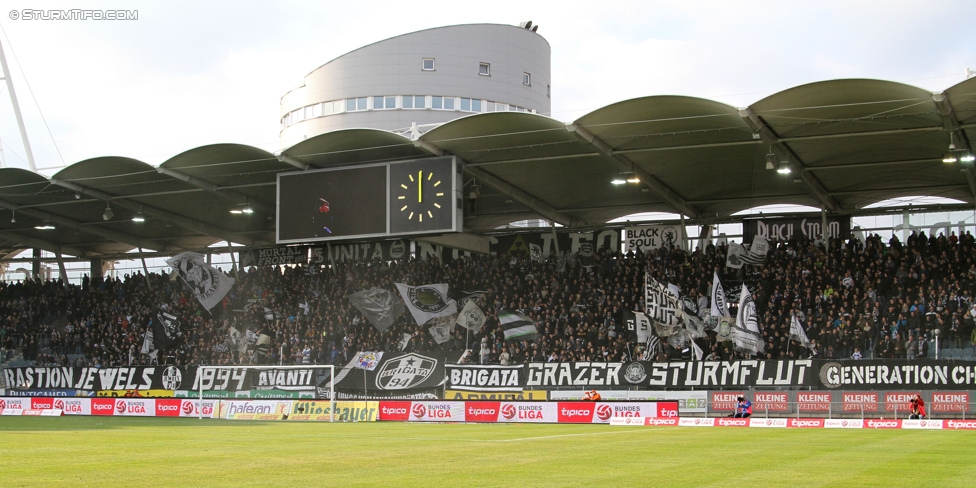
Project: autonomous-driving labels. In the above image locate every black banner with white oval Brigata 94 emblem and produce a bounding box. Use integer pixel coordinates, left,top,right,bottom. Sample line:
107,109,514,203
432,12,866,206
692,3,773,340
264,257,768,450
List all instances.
336,351,461,394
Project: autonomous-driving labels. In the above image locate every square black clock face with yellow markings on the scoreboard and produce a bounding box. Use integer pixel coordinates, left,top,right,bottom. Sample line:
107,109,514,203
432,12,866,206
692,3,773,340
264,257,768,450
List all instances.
390,158,455,234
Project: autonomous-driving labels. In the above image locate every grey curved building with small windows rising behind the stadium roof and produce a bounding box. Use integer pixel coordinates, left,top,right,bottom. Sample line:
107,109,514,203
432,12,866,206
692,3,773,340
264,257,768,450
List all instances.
280,22,551,149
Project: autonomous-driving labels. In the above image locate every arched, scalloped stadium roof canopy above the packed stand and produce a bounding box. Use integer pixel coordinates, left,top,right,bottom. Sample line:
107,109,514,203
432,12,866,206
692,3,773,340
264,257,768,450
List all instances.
0,78,976,258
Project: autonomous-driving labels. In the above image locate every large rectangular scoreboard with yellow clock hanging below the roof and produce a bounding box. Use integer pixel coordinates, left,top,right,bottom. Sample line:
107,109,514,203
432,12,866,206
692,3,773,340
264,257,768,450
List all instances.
276,156,464,244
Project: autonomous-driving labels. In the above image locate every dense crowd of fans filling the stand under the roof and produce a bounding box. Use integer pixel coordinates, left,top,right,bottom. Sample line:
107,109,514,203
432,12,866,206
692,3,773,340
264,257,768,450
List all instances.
0,232,976,366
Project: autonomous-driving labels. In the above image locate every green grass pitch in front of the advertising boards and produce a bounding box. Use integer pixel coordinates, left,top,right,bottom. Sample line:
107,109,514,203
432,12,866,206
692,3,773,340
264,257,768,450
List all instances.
0,417,976,487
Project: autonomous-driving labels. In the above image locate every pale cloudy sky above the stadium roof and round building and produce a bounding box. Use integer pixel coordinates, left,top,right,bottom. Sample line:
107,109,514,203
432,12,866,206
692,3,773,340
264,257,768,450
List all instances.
0,0,976,174
